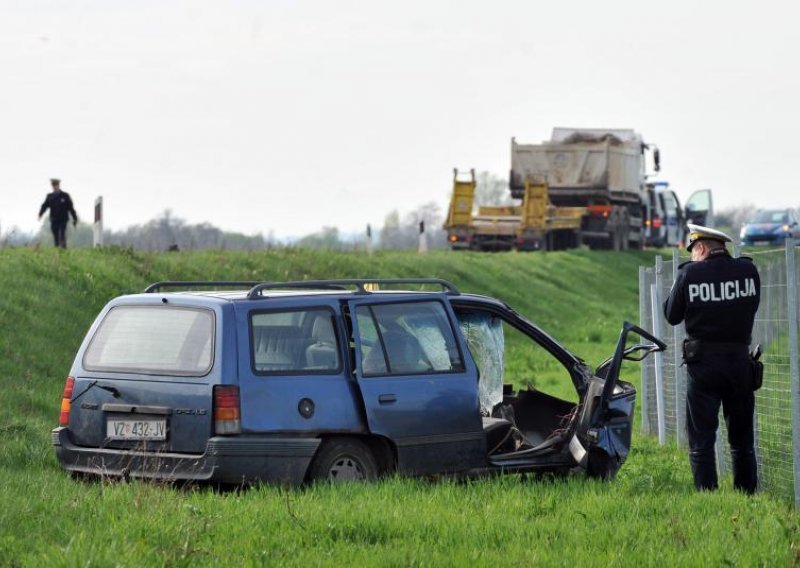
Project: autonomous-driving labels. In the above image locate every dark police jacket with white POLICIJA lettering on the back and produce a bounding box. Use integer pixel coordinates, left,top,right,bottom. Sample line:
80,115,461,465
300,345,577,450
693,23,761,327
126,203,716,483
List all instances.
664,250,761,345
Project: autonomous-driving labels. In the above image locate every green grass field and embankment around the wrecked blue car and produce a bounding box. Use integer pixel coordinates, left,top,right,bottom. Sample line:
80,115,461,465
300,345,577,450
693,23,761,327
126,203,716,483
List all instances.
0,249,800,566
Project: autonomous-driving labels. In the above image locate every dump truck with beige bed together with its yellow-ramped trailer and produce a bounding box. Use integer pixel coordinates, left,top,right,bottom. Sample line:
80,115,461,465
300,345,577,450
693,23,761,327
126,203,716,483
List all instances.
445,128,660,250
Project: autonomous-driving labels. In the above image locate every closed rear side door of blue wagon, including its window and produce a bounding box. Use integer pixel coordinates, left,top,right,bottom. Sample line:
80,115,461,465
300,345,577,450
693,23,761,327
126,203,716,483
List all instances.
349,297,486,474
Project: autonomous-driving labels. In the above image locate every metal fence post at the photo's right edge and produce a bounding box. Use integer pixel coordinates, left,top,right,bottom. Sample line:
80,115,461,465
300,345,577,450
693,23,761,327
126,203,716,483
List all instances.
786,239,800,507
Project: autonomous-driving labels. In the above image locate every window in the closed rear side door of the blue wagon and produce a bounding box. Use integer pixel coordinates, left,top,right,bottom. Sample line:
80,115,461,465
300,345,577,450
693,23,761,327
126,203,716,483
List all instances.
356,301,464,376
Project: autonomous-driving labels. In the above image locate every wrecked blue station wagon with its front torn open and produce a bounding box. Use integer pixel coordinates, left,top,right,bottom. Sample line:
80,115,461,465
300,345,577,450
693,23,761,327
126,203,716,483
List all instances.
52,279,664,484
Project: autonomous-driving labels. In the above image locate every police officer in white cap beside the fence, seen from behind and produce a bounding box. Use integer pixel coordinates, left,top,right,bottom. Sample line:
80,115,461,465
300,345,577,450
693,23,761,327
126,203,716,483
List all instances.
664,223,761,493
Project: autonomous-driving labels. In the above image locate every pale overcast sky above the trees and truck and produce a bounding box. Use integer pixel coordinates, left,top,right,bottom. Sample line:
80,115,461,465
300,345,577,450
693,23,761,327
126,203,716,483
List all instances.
0,0,800,237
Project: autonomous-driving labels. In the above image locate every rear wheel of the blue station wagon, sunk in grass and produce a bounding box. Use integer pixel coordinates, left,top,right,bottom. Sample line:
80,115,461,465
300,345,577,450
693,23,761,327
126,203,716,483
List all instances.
308,438,378,483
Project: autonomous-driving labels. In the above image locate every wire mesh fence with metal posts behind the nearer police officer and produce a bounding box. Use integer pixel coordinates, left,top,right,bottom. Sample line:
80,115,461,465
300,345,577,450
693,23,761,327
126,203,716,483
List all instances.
639,241,800,505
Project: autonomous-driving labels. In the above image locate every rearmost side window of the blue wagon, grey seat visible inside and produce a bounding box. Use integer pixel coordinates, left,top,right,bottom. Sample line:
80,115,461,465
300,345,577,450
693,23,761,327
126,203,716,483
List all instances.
250,308,341,375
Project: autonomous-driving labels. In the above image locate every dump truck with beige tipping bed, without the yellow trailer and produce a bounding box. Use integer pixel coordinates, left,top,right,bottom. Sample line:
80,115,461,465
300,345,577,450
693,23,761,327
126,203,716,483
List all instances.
509,128,660,250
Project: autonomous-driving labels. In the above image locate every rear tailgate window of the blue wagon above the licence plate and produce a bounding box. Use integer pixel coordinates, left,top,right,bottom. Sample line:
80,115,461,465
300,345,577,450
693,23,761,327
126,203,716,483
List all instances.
83,306,214,377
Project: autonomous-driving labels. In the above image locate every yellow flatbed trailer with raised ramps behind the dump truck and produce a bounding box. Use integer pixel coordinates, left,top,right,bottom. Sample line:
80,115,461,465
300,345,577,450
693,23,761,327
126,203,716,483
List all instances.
445,169,585,251
